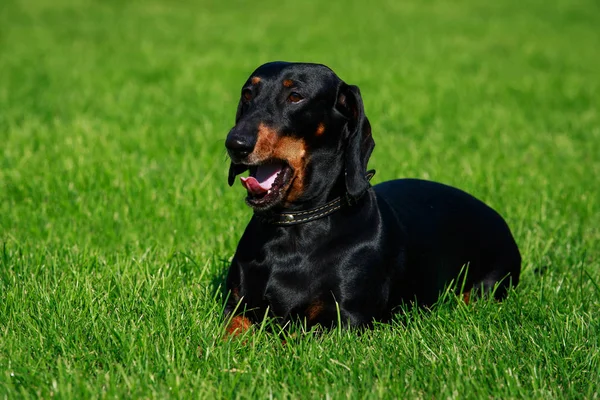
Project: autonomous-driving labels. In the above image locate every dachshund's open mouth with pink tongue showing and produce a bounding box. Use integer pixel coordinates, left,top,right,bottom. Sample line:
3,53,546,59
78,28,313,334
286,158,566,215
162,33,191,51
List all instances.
240,160,294,211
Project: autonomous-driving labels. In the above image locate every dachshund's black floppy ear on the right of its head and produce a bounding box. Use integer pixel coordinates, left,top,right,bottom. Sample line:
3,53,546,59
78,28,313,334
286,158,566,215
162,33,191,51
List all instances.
335,83,375,201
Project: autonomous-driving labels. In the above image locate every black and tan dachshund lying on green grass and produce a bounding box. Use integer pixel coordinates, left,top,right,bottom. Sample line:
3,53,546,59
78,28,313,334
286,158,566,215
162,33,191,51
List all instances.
225,62,521,333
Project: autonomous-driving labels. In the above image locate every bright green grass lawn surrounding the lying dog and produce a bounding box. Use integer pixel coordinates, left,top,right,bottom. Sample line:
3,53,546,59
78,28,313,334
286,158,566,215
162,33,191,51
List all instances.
0,0,600,399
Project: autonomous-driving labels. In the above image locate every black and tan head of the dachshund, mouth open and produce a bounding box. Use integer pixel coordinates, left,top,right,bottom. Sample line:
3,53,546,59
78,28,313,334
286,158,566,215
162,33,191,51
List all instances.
225,62,375,211
